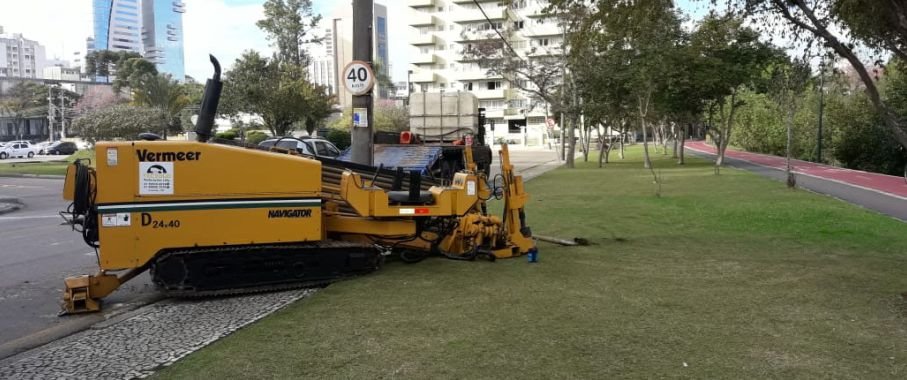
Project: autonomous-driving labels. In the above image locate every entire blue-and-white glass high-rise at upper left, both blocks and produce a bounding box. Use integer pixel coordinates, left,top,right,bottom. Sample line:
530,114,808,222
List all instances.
88,0,186,80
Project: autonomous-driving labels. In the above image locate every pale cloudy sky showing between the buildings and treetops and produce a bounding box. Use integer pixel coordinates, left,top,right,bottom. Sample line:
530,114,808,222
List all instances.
0,0,708,81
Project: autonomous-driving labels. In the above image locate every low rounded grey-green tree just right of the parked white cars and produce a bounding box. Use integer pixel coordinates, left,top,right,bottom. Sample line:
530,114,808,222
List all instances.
73,105,166,144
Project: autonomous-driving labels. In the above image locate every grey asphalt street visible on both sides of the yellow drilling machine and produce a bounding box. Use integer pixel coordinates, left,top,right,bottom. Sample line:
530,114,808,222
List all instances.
0,147,560,358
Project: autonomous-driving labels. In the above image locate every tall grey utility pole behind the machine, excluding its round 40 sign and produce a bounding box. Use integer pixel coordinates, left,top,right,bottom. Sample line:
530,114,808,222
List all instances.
343,0,375,165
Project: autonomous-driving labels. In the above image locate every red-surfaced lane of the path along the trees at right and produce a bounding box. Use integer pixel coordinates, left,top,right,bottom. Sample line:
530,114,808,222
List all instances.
686,141,907,200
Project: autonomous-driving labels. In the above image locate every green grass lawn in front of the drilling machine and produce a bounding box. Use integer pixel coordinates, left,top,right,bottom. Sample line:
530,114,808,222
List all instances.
157,149,907,379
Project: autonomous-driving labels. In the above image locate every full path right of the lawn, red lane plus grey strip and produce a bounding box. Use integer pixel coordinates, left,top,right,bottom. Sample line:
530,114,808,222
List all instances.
686,142,907,221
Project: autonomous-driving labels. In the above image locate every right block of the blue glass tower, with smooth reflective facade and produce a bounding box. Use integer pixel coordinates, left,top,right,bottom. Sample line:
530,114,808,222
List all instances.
142,0,186,81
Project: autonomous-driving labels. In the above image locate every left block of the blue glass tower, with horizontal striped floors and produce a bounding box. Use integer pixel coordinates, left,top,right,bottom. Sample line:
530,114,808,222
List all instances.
94,0,142,54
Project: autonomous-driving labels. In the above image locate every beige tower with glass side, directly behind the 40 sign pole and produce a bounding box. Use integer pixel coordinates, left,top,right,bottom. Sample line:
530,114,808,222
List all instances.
306,4,393,108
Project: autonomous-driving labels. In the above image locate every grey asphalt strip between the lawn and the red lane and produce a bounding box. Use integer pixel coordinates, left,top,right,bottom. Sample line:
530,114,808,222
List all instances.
687,146,907,221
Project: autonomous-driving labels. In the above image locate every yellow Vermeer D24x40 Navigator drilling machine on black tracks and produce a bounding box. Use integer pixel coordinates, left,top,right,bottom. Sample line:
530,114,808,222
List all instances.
56,57,536,314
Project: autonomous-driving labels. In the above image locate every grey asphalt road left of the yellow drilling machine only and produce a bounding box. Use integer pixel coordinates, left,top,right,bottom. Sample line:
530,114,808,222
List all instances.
0,177,152,345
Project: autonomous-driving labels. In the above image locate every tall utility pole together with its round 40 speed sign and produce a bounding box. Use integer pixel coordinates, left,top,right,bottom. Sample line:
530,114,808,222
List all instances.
350,0,375,165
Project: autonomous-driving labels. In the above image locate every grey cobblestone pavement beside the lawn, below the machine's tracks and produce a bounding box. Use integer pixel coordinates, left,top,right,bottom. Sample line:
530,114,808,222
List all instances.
0,289,316,379
